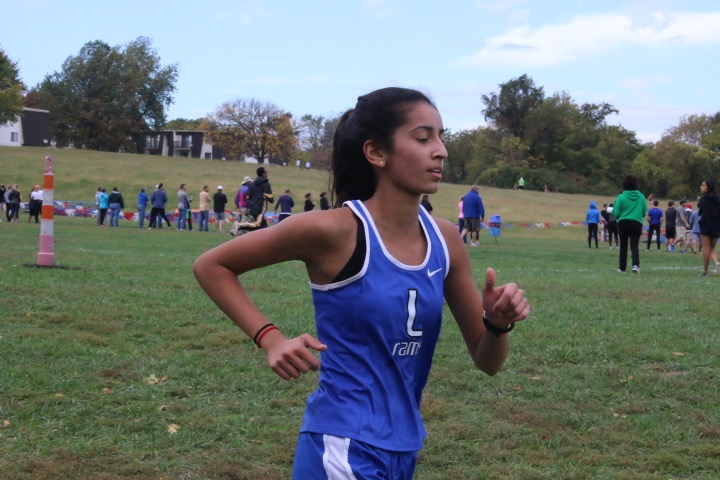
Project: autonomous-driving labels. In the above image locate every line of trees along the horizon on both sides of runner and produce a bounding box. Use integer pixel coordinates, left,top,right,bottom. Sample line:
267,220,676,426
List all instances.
0,37,720,198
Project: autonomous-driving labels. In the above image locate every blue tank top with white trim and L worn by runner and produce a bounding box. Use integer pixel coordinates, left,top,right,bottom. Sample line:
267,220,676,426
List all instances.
300,200,450,451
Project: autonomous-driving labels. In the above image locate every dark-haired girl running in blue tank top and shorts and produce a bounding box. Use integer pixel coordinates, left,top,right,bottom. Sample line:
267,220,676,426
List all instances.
193,88,530,480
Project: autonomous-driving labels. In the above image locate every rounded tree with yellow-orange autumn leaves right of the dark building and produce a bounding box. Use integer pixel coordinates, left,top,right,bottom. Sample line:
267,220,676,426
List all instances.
208,99,297,163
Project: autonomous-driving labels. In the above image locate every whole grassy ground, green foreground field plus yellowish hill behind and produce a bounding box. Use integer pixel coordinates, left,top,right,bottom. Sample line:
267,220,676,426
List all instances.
0,149,720,480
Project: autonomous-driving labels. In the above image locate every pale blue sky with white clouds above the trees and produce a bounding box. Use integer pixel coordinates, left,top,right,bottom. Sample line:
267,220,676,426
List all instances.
0,0,720,142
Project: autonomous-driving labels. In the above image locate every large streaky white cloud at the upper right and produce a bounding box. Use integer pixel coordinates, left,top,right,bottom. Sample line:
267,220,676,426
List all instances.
458,12,720,66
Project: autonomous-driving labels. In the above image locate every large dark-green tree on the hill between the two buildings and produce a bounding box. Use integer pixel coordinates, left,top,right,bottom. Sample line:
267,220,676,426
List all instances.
31,37,178,152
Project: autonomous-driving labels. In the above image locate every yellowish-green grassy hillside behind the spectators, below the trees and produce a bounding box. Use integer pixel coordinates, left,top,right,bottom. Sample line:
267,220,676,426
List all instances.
0,147,620,223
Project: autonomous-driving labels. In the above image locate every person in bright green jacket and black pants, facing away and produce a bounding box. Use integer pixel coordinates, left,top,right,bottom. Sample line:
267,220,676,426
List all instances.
613,175,647,273
